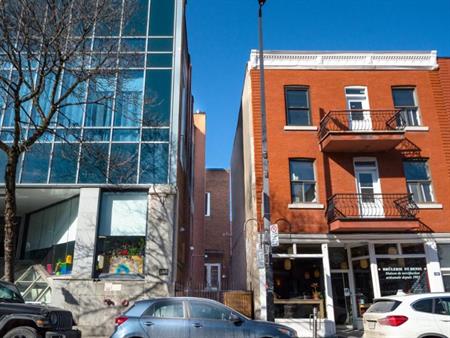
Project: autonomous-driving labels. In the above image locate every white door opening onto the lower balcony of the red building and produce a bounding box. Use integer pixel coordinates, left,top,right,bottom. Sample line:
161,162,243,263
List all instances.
355,160,384,217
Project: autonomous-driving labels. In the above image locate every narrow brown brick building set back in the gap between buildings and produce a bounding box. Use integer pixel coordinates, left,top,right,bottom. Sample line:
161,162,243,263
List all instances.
189,112,231,291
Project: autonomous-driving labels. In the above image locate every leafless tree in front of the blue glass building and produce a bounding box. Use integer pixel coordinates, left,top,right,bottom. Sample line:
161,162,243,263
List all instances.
0,0,130,282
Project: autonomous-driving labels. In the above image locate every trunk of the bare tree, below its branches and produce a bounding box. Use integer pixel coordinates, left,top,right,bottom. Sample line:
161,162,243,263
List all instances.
4,149,19,283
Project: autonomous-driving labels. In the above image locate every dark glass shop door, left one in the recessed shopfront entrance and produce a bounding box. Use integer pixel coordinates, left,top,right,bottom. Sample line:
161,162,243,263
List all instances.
331,271,353,326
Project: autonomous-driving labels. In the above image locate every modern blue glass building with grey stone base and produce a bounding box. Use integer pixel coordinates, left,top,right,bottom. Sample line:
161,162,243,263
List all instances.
0,0,192,335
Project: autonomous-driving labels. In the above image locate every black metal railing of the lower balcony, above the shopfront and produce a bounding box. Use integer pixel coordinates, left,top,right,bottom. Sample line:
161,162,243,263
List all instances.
326,194,419,223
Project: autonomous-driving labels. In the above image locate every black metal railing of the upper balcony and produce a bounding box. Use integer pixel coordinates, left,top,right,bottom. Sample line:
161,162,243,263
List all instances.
319,109,406,140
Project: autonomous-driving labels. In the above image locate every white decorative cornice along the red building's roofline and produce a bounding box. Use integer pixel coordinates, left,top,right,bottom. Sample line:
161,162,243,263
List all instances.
249,50,439,70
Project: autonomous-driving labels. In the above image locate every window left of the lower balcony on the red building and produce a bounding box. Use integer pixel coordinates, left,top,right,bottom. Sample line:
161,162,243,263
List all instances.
289,160,316,203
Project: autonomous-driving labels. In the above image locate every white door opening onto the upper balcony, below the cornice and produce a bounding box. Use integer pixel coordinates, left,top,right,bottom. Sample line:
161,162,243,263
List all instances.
345,87,372,131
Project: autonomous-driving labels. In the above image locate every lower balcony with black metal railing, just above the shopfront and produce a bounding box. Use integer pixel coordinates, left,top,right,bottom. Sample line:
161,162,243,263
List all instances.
326,194,419,231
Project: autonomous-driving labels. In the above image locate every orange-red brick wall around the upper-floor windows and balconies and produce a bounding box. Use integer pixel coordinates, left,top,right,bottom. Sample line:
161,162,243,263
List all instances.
250,65,450,233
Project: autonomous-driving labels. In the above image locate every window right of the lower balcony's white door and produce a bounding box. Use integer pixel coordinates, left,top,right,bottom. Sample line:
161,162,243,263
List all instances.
403,160,434,203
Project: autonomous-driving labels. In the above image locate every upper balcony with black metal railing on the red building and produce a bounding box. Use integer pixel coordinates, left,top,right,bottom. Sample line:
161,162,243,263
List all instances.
319,109,406,152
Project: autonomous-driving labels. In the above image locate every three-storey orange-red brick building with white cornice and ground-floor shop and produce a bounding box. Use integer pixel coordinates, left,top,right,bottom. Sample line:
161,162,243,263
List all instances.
231,51,450,336
